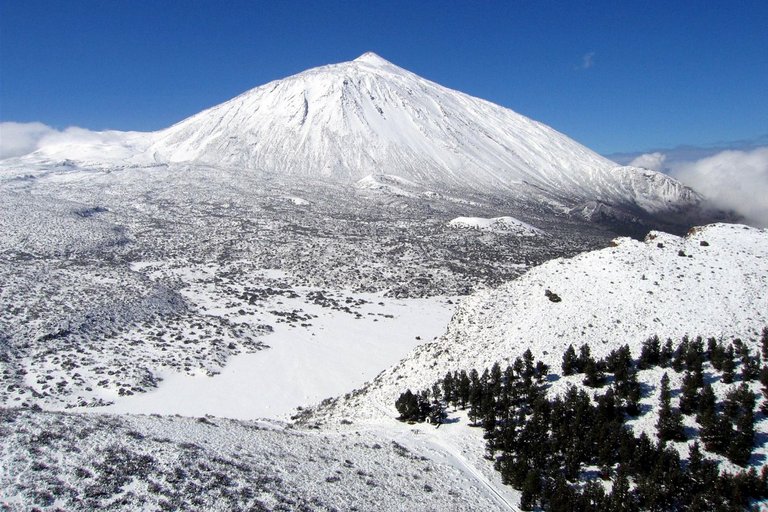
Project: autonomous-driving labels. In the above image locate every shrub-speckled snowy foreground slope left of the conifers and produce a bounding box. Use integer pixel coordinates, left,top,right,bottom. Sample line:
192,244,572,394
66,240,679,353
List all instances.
0,409,508,512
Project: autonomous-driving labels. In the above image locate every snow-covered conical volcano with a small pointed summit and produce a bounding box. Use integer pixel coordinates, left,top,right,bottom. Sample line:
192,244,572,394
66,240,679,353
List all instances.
144,53,700,213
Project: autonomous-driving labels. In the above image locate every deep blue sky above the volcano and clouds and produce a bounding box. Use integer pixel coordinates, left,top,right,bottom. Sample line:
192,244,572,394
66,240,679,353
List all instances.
0,0,768,153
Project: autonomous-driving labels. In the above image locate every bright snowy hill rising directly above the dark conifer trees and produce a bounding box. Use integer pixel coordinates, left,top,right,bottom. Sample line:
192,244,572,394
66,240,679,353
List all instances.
310,224,768,417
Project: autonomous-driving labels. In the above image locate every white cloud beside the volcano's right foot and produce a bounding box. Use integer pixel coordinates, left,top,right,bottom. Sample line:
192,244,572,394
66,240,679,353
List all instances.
669,147,768,227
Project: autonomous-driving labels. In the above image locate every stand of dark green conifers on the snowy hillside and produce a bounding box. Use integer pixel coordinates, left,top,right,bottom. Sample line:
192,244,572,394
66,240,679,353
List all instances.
395,328,768,511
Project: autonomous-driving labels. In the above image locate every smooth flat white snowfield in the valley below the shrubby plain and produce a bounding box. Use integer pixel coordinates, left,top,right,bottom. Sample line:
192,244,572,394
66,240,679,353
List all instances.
100,294,454,420
